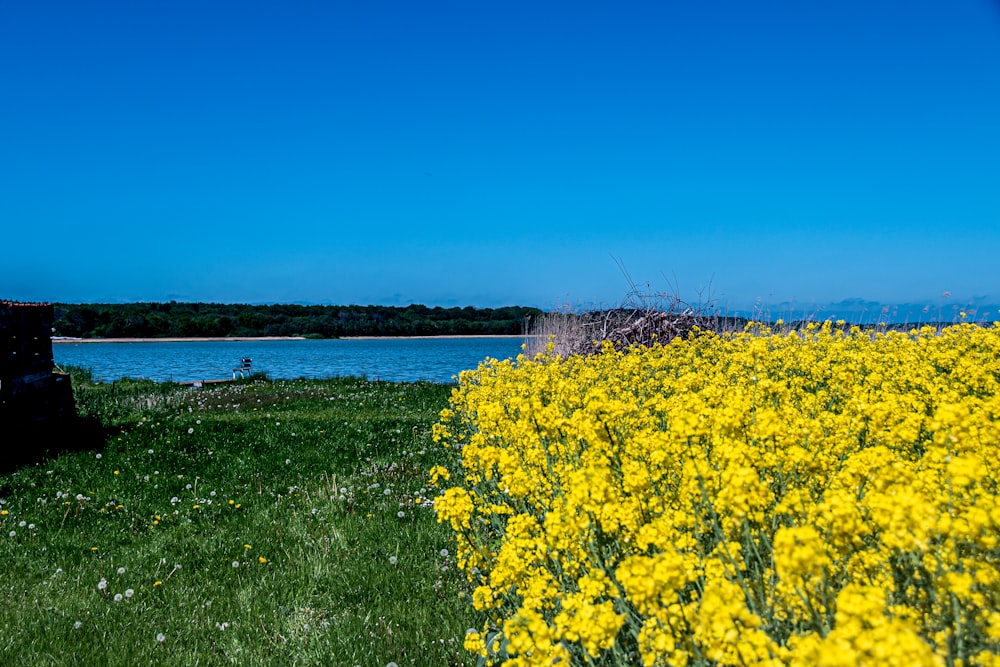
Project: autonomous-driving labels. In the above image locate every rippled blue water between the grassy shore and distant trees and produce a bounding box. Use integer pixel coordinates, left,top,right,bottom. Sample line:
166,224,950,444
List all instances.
52,337,524,382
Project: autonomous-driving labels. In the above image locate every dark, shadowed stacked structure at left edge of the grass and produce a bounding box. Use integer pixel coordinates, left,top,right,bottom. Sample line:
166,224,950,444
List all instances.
0,301,76,470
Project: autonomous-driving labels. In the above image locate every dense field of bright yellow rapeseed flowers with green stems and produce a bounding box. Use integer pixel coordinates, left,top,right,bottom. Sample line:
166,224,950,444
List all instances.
433,322,1000,666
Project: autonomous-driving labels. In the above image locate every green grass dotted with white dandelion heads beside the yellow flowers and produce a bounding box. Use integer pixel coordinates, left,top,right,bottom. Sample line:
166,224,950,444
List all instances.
0,373,481,667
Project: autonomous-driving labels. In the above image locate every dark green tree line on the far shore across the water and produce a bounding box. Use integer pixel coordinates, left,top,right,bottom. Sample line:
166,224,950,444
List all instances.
53,301,542,338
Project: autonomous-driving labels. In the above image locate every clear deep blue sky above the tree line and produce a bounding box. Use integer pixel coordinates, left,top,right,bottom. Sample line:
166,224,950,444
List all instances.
0,0,1000,314
